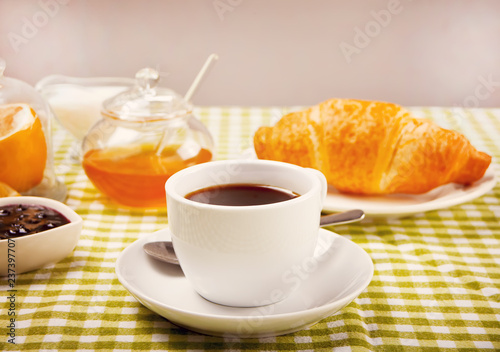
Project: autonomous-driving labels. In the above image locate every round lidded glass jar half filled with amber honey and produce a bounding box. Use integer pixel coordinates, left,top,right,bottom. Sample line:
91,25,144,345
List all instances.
82,68,213,208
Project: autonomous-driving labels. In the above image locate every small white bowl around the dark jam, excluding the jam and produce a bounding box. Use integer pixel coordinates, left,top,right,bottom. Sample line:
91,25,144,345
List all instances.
0,197,83,276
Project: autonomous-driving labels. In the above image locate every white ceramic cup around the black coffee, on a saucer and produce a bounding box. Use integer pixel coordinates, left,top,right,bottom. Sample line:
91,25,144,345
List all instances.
165,160,327,307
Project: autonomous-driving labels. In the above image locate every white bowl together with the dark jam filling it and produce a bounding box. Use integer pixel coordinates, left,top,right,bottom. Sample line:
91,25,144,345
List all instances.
0,196,83,277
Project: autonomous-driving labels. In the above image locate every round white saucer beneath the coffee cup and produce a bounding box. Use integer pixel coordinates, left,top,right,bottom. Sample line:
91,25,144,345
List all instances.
115,229,373,337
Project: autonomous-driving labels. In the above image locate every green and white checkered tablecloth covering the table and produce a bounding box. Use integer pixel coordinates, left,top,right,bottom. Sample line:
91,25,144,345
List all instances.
0,108,500,351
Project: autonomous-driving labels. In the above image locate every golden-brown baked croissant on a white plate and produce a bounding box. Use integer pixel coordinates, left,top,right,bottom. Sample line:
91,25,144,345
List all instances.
254,99,491,195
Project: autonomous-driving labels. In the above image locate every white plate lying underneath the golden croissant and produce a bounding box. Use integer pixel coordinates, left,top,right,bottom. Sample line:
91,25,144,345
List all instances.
323,166,496,217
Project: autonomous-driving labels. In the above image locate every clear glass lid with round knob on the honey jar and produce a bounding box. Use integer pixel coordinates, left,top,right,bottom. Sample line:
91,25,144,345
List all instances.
102,68,193,122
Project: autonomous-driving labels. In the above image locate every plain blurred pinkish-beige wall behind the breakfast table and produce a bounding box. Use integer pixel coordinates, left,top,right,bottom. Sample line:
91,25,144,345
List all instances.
0,0,500,107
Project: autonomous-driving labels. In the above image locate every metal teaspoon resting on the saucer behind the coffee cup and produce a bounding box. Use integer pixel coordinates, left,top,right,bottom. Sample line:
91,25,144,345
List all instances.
142,209,365,265
